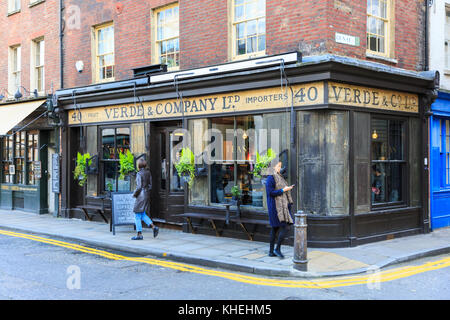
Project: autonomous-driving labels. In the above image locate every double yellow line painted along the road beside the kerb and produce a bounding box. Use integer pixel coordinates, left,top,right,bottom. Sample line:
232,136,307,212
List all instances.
0,230,450,289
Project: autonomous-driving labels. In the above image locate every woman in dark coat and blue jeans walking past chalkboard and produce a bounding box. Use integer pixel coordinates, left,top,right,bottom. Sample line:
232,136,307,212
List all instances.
131,158,159,240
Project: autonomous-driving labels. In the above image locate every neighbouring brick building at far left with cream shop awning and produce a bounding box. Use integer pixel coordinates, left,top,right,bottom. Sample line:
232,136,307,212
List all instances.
0,0,61,213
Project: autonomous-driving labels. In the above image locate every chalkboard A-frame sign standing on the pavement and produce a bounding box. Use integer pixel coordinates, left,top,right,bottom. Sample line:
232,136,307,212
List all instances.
111,192,135,235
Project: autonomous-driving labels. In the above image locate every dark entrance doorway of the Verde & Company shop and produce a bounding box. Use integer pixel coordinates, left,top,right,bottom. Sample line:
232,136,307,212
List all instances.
150,121,185,225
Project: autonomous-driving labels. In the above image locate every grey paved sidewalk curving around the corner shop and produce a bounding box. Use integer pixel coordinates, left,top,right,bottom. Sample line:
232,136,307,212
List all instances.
0,210,450,278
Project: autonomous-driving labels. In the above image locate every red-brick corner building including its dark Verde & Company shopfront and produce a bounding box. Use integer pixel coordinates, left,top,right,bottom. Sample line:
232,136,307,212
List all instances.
22,0,436,246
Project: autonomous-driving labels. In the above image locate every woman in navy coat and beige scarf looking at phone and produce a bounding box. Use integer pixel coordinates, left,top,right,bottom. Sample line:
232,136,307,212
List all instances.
266,161,294,258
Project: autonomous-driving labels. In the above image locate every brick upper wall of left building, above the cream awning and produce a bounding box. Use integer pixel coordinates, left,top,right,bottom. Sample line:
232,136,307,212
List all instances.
0,0,60,97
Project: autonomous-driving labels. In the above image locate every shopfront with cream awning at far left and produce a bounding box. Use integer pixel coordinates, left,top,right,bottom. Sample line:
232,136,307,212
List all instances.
0,99,56,214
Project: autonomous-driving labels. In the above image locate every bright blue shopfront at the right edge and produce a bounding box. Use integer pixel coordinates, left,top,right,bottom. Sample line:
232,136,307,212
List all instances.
430,91,450,229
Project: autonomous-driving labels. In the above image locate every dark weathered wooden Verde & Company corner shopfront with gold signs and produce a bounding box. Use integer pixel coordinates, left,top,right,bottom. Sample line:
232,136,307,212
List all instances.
57,56,435,247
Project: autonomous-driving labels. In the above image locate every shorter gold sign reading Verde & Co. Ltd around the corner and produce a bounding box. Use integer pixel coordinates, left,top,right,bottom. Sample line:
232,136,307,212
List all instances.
328,82,419,113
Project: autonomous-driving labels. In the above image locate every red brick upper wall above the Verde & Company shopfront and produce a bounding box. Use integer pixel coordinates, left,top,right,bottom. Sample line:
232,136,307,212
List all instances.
59,0,424,87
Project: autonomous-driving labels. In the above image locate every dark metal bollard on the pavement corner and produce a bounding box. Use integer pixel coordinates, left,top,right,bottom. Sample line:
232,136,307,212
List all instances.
292,210,308,271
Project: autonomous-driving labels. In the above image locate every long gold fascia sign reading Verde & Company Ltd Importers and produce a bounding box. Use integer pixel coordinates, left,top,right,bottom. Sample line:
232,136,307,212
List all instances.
69,82,324,125
